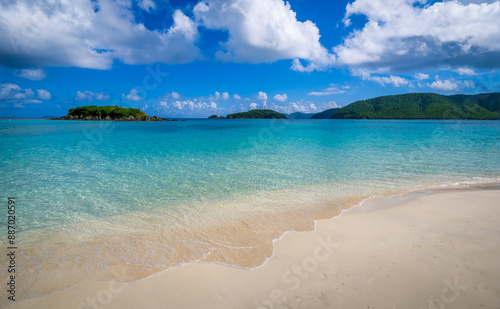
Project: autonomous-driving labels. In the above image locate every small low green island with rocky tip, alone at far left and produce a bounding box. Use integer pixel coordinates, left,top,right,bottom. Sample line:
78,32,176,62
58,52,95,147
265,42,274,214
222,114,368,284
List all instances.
51,105,174,121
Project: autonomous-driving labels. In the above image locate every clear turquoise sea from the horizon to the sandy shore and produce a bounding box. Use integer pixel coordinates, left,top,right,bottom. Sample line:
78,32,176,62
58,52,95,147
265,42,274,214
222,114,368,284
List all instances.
0,119,500,295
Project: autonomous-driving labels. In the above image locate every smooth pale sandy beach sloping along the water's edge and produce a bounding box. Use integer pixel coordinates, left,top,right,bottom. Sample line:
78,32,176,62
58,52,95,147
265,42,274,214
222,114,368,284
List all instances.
7,185,500,309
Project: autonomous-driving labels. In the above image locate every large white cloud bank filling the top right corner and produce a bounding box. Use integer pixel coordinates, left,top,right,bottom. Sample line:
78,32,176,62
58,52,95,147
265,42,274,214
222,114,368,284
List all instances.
333,0,500,71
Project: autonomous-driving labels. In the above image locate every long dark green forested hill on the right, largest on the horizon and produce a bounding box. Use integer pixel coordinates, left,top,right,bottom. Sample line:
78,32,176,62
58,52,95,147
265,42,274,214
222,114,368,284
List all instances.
331,93,500,120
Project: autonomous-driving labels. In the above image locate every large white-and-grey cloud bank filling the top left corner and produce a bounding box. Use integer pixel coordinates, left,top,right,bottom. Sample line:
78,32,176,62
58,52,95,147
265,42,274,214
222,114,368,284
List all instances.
0,0,200,69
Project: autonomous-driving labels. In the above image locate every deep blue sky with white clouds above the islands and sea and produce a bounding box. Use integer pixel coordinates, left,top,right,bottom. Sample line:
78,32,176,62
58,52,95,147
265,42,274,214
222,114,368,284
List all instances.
0,0,500,118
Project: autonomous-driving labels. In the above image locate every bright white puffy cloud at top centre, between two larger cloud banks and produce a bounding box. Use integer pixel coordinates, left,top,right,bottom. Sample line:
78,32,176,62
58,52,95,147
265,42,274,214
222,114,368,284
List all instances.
193,0,335,71
